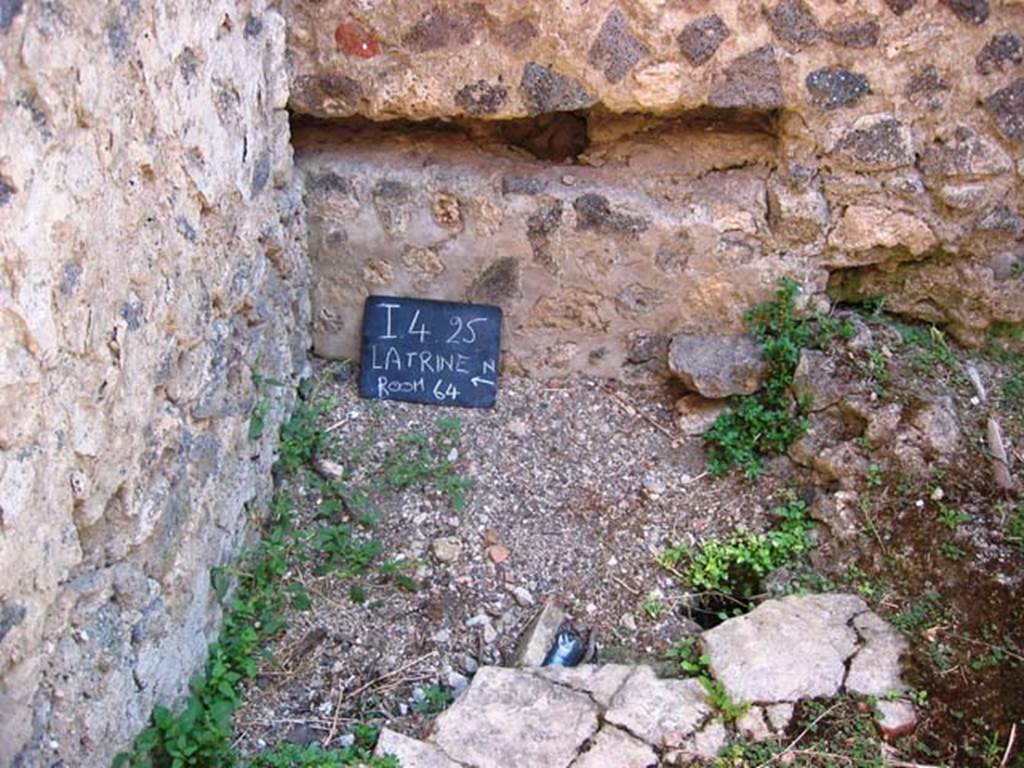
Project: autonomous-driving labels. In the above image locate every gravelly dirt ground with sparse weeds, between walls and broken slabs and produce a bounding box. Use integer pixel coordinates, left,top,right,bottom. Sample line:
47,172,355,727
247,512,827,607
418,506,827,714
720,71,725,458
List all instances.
237,313,1024,768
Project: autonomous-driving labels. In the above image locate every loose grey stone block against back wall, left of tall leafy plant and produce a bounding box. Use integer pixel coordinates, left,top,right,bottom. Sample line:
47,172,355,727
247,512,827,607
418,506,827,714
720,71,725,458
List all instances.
669,334,767,398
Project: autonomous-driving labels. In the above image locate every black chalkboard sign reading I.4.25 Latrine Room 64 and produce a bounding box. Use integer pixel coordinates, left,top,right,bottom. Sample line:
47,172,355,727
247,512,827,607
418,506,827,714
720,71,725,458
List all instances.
359,296,502,408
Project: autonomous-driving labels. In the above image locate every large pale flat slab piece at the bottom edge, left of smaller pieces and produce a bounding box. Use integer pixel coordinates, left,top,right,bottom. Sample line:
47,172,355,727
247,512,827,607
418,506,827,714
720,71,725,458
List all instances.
433,667,599,768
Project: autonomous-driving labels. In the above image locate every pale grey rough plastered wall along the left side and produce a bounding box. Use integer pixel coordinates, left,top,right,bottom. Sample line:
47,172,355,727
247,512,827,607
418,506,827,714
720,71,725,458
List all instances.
0,0,308,767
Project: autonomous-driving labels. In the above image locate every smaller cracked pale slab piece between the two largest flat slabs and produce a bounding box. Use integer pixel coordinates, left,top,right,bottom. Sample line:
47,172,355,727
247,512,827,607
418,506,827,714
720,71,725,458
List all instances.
604,667,712,746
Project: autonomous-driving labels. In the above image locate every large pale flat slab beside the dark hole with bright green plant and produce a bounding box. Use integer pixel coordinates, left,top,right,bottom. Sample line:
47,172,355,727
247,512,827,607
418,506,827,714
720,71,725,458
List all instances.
701,594,867,703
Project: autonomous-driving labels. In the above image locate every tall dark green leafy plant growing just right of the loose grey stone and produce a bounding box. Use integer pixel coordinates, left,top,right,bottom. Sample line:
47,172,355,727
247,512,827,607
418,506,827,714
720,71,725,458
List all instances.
705,279,814,478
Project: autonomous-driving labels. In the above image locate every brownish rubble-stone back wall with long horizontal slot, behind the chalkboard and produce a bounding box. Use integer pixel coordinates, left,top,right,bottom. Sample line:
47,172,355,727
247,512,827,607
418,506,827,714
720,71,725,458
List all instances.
284,0,1024,375
